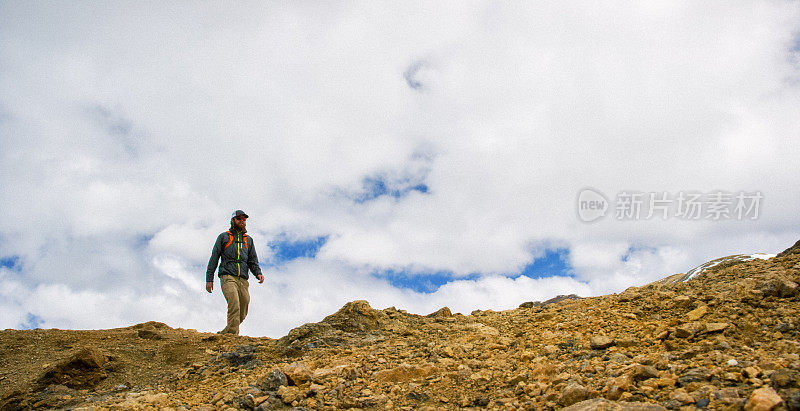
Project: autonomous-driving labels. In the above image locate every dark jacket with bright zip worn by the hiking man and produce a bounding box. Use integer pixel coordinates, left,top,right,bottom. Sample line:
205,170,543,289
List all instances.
206,230,261,282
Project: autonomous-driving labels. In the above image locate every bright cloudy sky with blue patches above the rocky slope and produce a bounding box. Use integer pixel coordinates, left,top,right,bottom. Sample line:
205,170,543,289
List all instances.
0,1,800,337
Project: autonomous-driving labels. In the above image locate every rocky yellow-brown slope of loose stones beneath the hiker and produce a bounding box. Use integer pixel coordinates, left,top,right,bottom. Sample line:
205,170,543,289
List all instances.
0,242,800,410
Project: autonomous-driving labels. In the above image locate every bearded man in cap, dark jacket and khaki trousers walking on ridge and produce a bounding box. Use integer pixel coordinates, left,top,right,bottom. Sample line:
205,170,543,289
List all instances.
206,210,264,335
